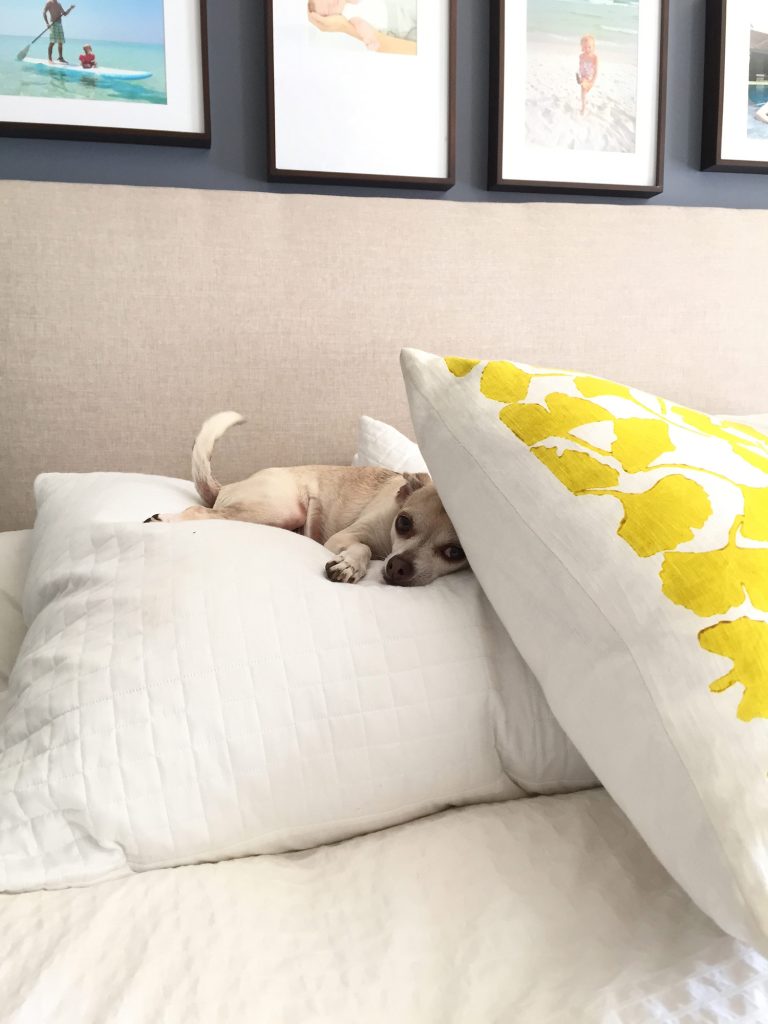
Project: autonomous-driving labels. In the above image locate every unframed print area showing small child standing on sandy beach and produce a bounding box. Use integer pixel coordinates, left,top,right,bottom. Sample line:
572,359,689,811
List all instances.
525,0,639,153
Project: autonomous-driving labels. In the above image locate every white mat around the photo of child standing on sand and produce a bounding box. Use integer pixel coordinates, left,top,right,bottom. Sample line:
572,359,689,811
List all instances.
500,0,663,187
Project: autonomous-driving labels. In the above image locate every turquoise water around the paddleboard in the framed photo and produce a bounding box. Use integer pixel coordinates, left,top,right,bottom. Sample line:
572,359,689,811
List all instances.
0,35,168,103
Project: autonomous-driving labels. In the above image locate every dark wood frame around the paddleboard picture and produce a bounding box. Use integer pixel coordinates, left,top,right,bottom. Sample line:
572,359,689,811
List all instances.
0,0,211,148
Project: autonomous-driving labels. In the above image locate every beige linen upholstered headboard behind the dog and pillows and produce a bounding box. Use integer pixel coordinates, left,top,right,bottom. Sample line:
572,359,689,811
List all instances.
0,181,768,529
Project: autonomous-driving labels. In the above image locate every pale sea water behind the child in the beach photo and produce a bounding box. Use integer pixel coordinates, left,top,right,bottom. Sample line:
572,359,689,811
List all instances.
528,0,639,51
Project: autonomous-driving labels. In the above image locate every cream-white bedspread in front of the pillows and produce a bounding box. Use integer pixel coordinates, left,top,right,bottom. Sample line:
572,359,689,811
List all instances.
0,791,768,1024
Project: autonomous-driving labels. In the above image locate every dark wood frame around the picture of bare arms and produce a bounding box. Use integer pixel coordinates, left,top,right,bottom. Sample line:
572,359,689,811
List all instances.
264,0,458,191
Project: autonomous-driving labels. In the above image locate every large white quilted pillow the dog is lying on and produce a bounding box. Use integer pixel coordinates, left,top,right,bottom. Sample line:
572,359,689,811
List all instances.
0,473,595,891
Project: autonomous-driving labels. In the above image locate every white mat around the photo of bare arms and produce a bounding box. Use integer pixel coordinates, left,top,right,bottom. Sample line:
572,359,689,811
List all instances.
272,0,451,178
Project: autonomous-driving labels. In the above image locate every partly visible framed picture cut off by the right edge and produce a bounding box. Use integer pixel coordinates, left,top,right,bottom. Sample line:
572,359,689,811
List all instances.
701,0,768,174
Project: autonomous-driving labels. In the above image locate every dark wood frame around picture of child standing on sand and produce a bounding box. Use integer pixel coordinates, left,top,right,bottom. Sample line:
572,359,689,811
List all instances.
487,0,670,199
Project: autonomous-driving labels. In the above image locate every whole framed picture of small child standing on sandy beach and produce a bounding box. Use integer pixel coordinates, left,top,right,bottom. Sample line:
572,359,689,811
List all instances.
488,0,669,198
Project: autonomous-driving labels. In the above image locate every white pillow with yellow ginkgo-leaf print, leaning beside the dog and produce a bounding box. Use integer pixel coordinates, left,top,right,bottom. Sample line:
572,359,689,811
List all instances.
402,350,768,948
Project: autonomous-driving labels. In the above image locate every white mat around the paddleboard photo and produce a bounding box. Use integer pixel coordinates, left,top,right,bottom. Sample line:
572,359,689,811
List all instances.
0,0,206,134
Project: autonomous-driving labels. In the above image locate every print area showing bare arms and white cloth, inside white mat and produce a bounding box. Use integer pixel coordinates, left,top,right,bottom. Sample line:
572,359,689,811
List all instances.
307,0,418,56
